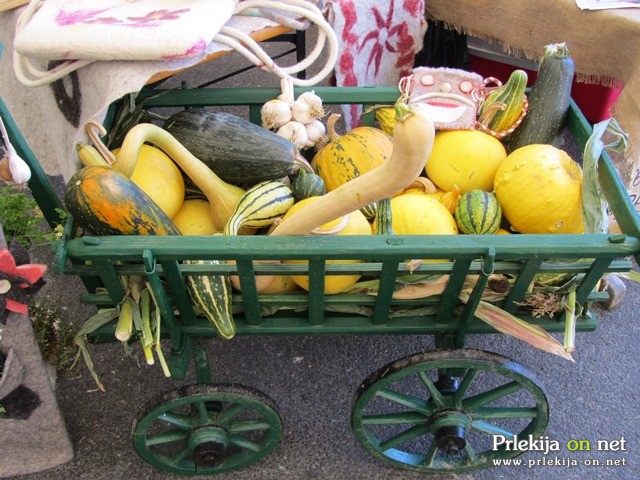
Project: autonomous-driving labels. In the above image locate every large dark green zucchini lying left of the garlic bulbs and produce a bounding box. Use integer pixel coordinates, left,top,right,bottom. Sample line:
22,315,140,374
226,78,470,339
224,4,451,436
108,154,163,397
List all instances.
164,108,300,186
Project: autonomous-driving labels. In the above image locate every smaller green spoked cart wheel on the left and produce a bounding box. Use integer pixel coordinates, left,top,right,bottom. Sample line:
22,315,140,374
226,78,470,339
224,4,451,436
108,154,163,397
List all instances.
133,384,282,475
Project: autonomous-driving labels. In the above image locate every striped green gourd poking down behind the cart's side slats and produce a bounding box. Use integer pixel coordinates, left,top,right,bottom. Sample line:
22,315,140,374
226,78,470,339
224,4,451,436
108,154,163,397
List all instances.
183,260,236,339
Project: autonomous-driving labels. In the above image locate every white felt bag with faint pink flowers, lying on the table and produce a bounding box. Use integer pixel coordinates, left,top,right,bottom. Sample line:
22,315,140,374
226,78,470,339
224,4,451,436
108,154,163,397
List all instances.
15,0,238,60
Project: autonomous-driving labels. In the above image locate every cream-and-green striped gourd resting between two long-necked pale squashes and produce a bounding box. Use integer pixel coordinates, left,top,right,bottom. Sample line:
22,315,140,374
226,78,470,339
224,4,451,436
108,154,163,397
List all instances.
224,180,295,235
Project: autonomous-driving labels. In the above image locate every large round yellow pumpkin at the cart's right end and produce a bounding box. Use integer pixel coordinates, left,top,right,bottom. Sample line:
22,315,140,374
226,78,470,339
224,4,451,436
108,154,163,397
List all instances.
494,144,584,233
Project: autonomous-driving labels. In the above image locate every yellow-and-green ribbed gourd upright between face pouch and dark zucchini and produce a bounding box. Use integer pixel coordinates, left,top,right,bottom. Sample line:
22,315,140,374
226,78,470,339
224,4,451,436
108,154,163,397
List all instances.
478,70,528,132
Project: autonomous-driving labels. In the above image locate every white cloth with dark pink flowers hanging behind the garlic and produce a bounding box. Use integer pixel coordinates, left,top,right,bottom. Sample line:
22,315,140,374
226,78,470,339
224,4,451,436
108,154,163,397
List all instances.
328,0,427,126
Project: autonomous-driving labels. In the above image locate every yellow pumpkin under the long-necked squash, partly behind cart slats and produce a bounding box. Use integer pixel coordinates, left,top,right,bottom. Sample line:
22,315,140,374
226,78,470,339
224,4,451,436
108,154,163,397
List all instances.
282,197,371,294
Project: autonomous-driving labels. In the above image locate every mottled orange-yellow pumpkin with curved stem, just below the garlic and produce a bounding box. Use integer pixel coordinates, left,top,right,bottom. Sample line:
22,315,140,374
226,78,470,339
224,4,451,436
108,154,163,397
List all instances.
311,114,393,192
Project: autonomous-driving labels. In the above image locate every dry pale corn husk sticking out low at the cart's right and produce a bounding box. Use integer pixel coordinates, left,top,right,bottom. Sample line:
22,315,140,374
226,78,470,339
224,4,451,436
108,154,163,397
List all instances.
464,301,574,362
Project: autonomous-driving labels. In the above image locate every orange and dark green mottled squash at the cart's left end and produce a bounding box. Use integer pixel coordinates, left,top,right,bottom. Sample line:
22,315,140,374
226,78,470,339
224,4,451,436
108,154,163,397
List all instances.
64,165,180,235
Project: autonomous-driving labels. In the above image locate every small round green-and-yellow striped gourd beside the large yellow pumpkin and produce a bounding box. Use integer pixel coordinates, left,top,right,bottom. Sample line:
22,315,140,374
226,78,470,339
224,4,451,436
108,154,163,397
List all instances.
454,190,502,234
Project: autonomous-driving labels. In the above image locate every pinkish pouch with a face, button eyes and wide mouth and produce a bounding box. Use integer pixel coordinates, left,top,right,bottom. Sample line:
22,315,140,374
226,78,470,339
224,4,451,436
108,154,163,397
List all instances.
409,67,483,130
